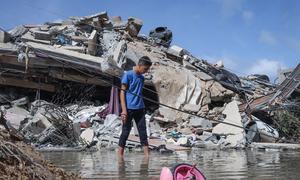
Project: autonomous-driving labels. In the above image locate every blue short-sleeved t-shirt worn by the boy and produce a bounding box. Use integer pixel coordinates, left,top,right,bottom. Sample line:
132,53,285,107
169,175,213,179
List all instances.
121,70,145,109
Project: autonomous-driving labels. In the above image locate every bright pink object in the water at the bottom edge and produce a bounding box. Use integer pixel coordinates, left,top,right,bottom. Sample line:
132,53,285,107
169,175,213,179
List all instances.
160,164,205,180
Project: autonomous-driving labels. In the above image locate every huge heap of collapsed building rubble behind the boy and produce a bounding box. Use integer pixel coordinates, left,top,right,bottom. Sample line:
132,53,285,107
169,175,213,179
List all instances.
0,12,300,153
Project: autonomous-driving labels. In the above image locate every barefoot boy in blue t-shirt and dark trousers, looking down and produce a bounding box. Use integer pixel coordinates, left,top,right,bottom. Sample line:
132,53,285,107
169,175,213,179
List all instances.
118,56,152,157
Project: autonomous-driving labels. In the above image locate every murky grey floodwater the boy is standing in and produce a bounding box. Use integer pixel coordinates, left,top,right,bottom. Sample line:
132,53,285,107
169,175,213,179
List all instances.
43,150,300,180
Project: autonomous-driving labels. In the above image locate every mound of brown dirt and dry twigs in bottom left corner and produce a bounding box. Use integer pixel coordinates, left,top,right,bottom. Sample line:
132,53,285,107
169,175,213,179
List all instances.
0,125,80,179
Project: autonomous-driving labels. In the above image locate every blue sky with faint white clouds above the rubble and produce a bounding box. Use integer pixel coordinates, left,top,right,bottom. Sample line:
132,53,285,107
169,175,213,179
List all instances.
0,0,300,80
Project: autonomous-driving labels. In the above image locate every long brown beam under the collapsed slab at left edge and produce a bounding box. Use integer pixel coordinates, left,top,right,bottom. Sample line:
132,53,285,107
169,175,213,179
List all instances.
0,76,55,92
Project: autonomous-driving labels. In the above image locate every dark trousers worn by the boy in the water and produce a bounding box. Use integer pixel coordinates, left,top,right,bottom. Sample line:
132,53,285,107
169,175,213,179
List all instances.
119,109,148,147
